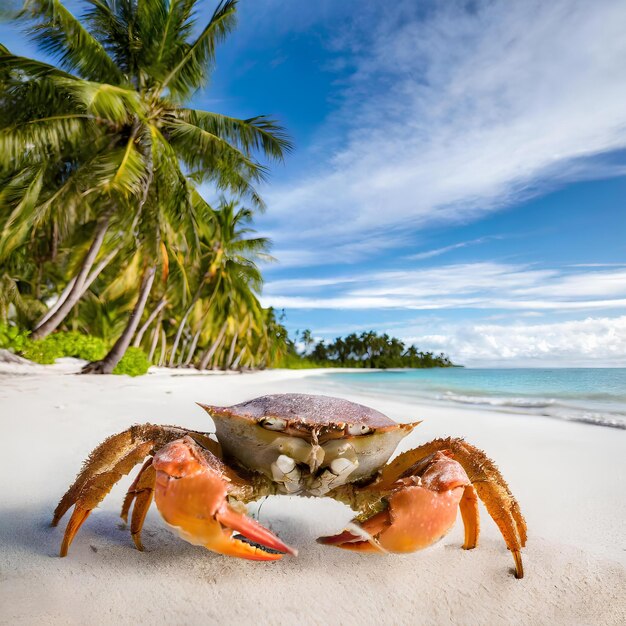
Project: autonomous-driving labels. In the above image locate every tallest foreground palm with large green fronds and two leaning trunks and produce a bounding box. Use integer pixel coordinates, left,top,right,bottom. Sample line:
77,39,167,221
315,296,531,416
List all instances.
0,0,290,373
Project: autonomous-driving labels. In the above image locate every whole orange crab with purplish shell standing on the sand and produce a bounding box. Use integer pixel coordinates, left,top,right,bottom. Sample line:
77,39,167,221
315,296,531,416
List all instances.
52,394,526,578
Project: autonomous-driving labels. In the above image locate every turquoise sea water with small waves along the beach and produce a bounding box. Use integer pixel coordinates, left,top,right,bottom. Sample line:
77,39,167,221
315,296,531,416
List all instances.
316,368,626,429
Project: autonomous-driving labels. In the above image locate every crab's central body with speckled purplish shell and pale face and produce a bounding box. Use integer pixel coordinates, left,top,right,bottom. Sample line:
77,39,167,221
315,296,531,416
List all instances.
200,394,420,495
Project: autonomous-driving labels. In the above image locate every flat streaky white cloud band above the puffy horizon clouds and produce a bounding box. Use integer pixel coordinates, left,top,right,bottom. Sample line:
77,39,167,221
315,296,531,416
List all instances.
262,262,626,312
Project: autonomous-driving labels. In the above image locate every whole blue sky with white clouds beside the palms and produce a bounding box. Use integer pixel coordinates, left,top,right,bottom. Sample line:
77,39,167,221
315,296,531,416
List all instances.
0,0,626,367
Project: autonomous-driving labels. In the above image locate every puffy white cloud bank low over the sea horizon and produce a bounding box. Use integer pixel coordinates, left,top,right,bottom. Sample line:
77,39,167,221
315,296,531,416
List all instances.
403,315,626,367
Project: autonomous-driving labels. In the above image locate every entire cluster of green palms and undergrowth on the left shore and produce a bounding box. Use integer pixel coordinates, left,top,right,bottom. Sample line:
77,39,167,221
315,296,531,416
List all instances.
0,0,291,373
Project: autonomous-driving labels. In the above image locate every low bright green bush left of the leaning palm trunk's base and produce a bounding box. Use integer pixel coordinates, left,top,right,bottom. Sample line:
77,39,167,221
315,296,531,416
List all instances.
20,331,107,365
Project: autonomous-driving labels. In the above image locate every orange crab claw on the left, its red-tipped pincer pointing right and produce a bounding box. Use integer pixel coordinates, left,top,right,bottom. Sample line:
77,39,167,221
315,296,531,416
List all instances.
152,437,297,561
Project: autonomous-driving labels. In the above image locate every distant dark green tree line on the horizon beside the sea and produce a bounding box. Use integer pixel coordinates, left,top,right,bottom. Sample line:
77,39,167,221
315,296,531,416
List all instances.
294,330,454,369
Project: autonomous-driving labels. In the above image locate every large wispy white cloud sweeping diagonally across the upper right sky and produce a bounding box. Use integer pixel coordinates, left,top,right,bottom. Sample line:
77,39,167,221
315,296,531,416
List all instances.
265,0,626,261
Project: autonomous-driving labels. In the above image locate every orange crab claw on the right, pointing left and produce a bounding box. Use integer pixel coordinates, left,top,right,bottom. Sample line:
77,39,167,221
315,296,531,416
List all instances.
318,452,470,552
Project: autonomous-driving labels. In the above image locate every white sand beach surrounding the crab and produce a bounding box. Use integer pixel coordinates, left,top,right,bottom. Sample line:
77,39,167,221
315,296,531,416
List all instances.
0,363,626,624
